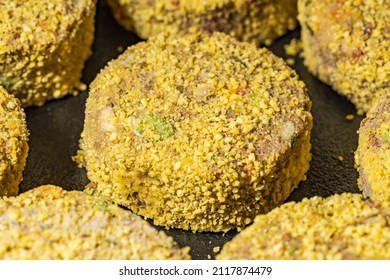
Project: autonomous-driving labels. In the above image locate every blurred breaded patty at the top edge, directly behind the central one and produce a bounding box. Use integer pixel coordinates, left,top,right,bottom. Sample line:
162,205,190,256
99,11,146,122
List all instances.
108,0,297,44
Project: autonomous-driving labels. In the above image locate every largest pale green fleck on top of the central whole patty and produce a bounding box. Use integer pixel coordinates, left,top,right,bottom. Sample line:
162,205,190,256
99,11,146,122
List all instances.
134,114,173,141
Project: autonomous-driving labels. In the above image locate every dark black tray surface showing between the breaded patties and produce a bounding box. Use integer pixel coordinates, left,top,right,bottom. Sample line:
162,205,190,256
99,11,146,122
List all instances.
20,1,362,259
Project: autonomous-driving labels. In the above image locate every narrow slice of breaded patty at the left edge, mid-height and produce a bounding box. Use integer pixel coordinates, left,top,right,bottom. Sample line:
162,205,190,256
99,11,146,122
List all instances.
0,86,28,197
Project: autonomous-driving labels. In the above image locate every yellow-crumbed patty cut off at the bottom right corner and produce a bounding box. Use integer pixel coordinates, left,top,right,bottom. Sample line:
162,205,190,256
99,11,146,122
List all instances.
216,193,390,260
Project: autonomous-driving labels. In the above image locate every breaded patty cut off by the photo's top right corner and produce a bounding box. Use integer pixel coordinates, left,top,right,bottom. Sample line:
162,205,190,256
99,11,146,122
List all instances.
298,0,390,114
